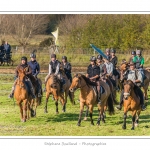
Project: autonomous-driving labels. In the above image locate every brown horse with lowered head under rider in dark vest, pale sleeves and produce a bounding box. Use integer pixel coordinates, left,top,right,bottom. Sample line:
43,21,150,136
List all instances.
44,74,66,114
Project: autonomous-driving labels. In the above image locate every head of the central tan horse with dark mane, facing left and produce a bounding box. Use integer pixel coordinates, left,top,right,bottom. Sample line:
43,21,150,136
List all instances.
69,74,82,92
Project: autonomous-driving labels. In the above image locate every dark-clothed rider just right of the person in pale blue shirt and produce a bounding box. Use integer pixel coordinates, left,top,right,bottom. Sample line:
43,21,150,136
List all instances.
110,49,119,90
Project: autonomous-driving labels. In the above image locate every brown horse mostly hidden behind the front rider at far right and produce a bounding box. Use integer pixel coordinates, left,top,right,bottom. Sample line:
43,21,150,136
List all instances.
120,62,150,100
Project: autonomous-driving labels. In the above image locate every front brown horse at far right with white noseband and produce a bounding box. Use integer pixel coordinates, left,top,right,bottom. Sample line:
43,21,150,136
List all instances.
122,80,141,130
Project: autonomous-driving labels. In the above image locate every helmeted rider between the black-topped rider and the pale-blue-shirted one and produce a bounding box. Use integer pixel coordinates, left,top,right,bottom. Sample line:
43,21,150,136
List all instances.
97,55,107,78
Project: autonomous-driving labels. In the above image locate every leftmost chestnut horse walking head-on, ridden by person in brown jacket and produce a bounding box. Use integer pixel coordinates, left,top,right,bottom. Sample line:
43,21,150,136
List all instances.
14,69,33,122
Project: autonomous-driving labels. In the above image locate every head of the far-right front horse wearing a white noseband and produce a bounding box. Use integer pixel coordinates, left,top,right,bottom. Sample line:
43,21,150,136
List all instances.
123,80,134,100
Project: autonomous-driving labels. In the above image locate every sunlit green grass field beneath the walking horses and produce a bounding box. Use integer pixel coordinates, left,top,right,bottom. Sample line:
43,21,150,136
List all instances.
0,75,150,136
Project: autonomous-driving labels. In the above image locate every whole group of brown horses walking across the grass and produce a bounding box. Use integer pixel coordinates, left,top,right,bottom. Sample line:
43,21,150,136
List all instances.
14,63,150,130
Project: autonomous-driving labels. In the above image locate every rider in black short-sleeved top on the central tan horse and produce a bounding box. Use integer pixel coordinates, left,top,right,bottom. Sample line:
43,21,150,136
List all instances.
86,56,101,104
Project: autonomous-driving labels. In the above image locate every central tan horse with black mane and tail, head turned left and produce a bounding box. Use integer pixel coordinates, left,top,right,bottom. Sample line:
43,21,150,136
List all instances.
69,74,114,126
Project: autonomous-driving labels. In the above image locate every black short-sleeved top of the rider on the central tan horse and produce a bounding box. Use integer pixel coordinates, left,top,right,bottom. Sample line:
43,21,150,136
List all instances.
87,65,100,78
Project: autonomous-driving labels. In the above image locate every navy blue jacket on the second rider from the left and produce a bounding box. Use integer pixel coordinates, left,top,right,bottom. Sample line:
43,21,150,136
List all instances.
28,60,40,76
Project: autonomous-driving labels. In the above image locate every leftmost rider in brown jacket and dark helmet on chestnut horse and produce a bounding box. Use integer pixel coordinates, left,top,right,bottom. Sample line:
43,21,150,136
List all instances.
9,56,35,99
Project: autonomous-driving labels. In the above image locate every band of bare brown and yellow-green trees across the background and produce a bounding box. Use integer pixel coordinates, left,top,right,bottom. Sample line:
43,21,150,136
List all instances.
0,14,150,51
